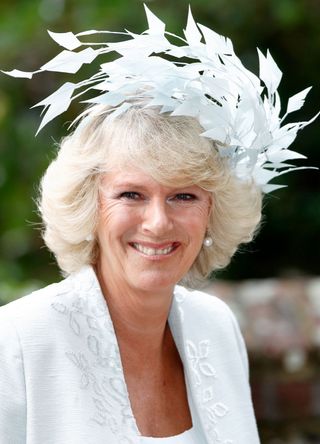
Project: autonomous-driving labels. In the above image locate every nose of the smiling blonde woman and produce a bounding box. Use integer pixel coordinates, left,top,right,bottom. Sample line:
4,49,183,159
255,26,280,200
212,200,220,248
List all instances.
142,199,173,237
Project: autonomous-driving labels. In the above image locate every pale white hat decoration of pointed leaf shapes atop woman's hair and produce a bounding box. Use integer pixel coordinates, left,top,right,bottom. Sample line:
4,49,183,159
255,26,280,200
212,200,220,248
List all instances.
3,6,320,192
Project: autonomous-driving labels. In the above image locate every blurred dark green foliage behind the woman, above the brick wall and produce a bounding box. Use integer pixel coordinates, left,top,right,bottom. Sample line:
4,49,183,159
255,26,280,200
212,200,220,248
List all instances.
0,0,320,303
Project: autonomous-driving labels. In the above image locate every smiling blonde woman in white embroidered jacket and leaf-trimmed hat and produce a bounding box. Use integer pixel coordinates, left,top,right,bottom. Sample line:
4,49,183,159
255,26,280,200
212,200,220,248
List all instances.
0,4,316,444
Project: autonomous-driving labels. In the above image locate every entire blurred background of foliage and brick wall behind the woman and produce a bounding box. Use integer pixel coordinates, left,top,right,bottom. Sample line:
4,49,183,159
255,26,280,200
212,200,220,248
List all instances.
0,0,320,444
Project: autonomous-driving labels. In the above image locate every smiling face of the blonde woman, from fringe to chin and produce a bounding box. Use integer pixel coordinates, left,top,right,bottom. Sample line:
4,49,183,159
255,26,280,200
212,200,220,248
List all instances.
97,168,211,291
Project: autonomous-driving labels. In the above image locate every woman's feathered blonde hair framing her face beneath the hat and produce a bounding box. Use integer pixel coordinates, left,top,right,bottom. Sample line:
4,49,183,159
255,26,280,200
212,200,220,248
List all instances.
39,104,262,286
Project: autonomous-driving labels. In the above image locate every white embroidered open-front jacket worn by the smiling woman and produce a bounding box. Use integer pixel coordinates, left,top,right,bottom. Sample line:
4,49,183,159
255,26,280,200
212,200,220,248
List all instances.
0,267,260,444
